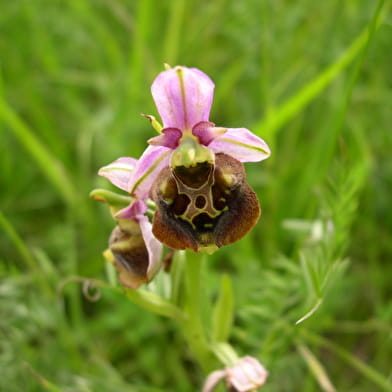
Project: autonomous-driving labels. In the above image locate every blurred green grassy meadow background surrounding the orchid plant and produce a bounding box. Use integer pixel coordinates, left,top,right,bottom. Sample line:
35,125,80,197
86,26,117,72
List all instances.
0,0,392,392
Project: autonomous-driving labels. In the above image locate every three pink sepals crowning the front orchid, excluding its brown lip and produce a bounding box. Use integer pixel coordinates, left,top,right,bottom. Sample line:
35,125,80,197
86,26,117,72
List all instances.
128,66,270,197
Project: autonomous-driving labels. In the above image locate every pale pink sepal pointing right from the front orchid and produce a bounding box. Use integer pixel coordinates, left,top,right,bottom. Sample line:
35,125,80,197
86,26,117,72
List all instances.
208,128,271,162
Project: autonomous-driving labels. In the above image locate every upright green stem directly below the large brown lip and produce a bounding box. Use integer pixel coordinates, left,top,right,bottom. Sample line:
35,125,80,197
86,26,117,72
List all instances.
181,251,216,372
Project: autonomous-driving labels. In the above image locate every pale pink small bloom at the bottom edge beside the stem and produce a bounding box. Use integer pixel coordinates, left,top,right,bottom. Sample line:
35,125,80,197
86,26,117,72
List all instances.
203,356,268,392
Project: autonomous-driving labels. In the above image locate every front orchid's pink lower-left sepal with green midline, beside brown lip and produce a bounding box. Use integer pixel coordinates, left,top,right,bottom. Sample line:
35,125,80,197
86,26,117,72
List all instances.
128,146,172,199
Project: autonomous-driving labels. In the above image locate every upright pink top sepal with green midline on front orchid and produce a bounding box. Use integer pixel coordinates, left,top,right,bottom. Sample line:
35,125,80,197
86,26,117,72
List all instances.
151,66,214,130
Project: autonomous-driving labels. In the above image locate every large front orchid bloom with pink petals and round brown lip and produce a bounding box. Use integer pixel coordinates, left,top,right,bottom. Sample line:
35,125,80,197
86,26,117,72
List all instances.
99,66,270,253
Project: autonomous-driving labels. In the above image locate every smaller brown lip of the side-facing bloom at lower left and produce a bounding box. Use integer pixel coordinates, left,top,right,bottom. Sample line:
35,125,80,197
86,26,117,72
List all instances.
109,224,148,289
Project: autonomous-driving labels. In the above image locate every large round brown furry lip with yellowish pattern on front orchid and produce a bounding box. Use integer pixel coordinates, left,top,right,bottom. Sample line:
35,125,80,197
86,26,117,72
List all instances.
151,153,261,253
